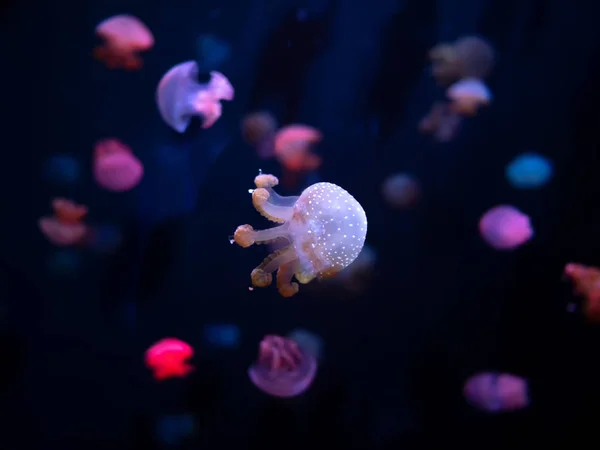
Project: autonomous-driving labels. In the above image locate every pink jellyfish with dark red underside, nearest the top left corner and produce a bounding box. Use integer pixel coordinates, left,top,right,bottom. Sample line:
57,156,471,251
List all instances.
94,14,154,70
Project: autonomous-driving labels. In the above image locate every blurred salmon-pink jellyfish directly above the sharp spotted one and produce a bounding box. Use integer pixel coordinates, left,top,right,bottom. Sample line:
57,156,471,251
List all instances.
275,125,322,186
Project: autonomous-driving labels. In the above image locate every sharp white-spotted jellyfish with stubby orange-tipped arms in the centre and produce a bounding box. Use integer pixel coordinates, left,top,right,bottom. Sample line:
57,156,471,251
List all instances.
233,174,367,297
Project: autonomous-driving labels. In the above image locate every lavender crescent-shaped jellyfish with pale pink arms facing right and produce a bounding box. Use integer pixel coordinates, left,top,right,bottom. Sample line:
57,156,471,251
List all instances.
156,61,234,133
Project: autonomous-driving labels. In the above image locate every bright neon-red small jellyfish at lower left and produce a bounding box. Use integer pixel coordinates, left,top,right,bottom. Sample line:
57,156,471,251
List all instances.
146,338,194,381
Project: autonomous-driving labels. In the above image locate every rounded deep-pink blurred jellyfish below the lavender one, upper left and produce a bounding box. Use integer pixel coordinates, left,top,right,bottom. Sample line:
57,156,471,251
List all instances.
93,139,144,192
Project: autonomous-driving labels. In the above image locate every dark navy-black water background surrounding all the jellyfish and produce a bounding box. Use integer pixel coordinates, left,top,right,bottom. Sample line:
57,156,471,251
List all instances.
0,0,600,449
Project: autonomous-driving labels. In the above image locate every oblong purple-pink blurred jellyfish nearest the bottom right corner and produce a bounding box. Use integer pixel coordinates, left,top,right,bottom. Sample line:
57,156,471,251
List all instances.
463,373,529,413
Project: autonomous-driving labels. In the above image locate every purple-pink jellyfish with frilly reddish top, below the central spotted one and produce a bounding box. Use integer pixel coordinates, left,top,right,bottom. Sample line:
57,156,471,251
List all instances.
248,336,317,398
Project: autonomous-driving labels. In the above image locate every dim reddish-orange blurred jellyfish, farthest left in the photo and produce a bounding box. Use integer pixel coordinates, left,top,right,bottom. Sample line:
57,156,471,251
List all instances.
38,198,89,246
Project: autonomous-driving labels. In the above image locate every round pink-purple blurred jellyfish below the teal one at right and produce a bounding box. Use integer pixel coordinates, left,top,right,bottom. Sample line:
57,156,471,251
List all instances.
479,205,533,250
